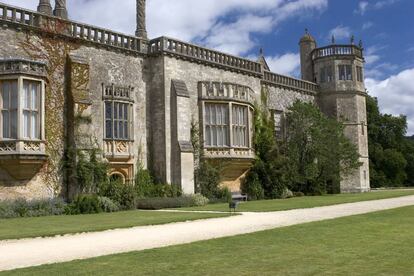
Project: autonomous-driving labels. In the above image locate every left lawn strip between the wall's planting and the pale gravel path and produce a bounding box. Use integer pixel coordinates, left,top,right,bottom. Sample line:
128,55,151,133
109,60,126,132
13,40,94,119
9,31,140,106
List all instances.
0,211,227,240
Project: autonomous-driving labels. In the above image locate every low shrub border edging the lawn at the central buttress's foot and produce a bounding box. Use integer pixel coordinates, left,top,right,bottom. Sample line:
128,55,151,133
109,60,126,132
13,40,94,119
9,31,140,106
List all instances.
137,195,209,210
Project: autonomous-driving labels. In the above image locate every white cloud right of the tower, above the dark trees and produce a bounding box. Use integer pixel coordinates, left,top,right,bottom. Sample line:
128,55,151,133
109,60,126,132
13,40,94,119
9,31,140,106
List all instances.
365,68,414,135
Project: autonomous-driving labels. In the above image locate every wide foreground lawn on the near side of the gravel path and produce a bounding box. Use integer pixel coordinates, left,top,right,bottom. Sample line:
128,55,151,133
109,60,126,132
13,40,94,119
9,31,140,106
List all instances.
4,206,414,276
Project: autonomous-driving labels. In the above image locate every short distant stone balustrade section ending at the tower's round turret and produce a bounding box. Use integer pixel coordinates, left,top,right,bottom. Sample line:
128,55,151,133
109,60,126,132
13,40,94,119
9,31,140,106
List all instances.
263,71,319,93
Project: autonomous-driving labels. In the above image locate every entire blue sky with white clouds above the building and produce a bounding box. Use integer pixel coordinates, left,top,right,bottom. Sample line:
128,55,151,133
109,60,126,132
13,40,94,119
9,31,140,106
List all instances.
0,0,414,134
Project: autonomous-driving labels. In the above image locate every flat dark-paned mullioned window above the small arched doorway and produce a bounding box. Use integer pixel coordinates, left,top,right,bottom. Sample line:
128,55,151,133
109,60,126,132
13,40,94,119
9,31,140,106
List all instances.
105,101,132,140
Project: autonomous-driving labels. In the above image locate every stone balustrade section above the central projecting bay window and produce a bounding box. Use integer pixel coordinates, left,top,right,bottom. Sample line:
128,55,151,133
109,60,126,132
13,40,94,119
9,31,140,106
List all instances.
149,37,262,75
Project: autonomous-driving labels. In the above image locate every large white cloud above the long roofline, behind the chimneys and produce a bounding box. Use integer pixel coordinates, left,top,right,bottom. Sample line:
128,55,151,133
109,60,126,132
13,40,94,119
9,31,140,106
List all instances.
2,0,328,55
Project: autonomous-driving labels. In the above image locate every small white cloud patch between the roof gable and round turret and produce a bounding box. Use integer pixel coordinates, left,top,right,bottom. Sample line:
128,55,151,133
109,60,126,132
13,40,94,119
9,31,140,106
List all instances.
266,53,300,77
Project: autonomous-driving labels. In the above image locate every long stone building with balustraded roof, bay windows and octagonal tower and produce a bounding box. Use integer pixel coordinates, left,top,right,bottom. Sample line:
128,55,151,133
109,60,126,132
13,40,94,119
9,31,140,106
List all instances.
0,0,370,199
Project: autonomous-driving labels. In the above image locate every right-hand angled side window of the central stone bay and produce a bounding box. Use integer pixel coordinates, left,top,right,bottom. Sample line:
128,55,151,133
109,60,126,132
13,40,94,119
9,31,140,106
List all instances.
232,104,249,147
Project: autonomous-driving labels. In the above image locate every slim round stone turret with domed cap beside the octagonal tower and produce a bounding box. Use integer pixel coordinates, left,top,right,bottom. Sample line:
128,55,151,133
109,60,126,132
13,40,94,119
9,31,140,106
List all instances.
299,29,316,82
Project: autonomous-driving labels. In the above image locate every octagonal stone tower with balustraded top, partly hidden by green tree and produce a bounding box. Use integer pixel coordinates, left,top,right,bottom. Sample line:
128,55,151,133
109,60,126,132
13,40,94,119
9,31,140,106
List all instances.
311,38,370,192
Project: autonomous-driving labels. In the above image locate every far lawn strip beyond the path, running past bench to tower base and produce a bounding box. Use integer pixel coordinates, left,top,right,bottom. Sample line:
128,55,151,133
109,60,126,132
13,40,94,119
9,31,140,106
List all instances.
181,189,414,212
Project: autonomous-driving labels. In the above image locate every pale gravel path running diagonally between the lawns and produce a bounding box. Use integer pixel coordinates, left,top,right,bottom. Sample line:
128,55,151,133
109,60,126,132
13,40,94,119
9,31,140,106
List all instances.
0,196,414,271
